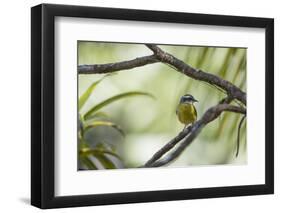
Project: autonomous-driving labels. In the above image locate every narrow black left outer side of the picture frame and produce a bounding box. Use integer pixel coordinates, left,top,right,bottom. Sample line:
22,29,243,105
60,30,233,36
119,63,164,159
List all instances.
31,5,43,208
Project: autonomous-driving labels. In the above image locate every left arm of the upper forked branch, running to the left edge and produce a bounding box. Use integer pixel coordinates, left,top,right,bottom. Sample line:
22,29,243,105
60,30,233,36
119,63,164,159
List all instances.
78,55,159,74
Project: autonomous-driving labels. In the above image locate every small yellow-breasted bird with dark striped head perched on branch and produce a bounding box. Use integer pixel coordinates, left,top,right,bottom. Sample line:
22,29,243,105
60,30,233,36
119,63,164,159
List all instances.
176,94,198,127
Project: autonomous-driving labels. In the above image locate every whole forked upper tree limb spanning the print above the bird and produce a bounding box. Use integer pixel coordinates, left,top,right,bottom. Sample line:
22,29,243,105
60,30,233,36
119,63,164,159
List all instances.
78,44,246,105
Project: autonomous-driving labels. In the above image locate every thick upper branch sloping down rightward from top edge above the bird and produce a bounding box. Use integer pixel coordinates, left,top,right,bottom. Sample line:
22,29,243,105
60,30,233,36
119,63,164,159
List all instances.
146,44,246,105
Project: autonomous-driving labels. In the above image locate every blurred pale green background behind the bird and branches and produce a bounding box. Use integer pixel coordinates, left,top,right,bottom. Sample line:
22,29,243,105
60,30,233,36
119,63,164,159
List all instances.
78,41,247,169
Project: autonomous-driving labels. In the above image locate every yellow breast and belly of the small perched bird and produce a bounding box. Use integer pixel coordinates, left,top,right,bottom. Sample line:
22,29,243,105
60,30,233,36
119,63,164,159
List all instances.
177,103,197,125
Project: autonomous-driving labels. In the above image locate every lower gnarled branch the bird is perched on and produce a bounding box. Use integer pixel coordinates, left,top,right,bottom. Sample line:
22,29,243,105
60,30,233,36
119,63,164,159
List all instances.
143,103,246,167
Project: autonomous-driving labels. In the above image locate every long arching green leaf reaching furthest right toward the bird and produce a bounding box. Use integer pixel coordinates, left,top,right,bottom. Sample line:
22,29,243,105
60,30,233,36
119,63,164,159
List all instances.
84,91,155,120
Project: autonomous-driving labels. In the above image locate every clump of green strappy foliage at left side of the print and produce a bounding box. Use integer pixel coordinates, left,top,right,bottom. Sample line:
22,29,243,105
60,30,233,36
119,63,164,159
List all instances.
78,74,154,170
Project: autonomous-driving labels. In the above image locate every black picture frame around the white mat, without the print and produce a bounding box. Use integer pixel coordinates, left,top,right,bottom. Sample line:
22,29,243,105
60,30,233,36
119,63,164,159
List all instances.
31,4,274,209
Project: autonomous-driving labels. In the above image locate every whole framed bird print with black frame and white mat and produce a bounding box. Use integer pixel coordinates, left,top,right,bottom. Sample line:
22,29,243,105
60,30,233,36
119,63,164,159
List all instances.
31,4,274,208
